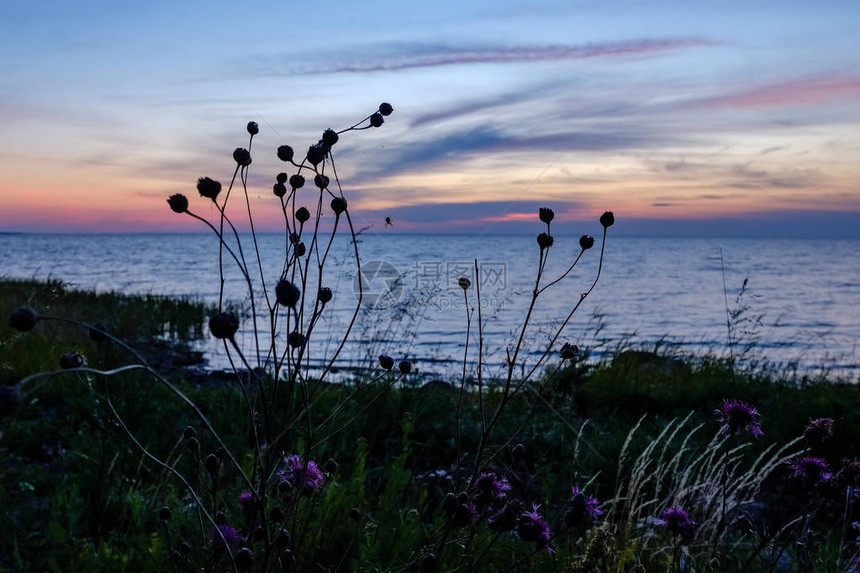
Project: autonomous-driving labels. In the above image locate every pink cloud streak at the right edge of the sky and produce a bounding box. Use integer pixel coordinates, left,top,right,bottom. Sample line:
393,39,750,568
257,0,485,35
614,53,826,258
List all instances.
701,75,860,109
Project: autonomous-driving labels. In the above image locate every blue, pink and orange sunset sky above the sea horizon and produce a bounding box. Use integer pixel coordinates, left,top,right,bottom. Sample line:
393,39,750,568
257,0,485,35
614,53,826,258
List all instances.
0,0,860,237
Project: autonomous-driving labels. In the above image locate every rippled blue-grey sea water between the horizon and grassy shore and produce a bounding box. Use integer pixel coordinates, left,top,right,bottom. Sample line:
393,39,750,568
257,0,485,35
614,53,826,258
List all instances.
0,233,860,379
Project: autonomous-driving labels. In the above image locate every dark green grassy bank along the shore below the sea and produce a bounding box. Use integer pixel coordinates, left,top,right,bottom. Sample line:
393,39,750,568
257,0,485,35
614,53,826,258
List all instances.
0,281,860,571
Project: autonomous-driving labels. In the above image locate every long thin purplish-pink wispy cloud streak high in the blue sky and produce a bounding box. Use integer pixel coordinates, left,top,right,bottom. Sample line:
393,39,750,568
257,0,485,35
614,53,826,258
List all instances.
247,38,715,75
